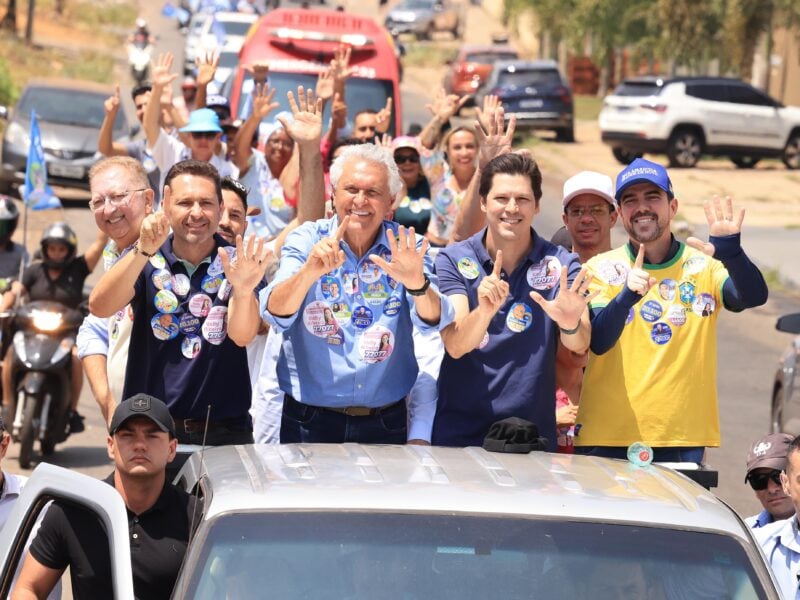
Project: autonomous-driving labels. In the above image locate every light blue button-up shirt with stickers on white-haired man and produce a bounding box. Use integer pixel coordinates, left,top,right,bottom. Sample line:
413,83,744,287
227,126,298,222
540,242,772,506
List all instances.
260,217,454,407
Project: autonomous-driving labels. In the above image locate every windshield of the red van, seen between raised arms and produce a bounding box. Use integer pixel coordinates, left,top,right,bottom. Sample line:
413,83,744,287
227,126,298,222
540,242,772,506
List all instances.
234,71,395,135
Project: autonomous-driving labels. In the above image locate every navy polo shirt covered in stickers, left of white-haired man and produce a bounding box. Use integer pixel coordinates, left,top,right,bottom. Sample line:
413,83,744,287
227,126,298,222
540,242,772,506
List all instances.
123,235,258,423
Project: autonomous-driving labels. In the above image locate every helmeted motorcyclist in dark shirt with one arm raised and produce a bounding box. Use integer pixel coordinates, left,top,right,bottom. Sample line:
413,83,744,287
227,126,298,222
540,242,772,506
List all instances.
0,222,108,433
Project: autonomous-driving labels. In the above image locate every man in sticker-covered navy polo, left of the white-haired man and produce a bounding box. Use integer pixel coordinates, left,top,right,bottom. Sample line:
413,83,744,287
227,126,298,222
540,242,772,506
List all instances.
89,160,267,445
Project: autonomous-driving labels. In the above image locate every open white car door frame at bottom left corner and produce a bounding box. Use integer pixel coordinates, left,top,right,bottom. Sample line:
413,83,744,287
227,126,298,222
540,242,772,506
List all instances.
0,463,134,600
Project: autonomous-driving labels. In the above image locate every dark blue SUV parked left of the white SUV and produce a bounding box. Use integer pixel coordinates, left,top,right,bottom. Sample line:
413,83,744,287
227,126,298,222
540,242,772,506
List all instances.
475,60,575,142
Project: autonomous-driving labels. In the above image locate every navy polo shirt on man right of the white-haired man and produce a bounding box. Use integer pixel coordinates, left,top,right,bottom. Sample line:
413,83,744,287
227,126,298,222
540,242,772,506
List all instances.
431,229,581,451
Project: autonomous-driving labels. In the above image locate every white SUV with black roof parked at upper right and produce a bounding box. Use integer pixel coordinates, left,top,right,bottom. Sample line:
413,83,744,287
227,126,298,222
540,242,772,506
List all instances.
599,77,800,169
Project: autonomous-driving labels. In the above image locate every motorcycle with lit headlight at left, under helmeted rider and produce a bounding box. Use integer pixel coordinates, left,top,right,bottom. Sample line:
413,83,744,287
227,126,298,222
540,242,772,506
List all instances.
5,301,84,469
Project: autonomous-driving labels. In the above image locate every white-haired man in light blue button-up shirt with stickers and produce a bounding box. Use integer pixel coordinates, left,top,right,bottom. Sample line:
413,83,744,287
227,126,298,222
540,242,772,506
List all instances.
260,144,452,443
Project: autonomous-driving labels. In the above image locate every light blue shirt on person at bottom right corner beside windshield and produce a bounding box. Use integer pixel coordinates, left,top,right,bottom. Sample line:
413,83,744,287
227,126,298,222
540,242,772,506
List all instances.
753,517,800,600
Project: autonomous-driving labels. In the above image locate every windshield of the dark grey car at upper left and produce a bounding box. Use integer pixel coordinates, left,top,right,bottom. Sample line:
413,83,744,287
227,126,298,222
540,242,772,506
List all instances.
16,87,125,131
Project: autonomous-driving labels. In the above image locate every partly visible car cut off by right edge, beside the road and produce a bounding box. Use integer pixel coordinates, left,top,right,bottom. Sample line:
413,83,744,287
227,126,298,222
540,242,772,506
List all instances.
771,313,800,435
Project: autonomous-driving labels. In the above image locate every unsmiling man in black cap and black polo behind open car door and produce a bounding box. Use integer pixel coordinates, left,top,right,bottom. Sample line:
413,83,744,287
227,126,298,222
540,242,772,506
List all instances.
11,394,202,600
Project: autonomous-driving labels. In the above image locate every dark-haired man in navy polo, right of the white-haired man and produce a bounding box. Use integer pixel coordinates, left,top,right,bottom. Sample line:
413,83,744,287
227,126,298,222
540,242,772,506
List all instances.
432,154,590,450
